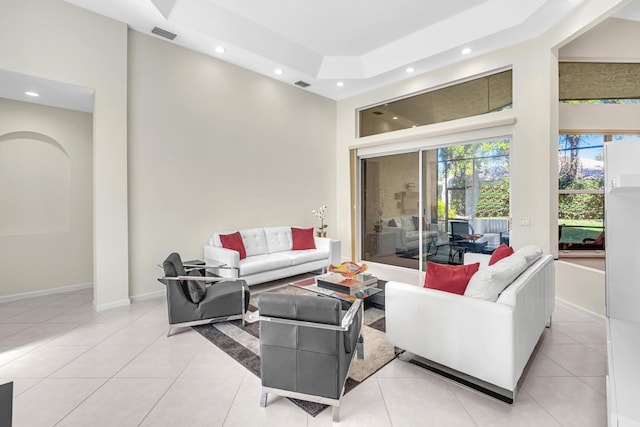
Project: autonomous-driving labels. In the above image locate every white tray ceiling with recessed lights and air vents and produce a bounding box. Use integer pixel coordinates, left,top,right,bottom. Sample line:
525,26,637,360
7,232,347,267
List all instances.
0,0,640,111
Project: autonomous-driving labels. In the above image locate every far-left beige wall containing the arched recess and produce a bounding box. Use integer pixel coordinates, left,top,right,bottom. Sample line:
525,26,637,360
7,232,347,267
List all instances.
0,99,93,298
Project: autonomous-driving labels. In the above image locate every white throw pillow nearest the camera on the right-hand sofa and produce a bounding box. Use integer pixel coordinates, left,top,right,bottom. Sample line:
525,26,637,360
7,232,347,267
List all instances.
464,253,528,302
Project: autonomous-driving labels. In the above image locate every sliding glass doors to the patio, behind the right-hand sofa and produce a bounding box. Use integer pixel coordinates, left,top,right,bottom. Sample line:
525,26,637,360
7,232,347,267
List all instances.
361,139,509,269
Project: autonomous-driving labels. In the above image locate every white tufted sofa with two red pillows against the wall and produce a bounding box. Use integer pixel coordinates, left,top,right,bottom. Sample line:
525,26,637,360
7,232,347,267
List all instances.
204,227,341,285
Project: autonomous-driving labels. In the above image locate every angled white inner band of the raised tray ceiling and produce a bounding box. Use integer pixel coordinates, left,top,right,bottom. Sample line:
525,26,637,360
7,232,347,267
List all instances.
153,0,547,79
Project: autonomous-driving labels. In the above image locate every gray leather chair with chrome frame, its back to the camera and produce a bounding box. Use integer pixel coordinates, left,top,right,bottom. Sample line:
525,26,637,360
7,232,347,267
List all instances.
258,293,364,422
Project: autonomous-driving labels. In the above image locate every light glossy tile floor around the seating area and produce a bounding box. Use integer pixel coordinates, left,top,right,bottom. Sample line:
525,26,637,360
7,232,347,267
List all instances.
0,290,606,427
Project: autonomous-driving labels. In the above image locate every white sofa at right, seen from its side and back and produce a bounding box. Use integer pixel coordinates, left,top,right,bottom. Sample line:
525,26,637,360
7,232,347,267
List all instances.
385,247,555,402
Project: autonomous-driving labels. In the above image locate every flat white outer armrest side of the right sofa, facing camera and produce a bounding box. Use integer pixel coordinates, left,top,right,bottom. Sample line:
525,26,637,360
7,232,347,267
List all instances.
385,282,517,390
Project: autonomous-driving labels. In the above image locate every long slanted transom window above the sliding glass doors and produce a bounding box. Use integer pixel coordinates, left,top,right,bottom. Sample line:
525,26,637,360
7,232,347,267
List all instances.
359,70,512,137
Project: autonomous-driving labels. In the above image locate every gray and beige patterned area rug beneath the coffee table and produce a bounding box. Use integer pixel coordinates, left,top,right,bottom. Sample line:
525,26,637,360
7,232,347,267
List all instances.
193,286,395,417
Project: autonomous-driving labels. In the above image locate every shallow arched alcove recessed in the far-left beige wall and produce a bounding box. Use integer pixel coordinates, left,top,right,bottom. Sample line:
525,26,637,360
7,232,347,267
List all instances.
0,131,71,235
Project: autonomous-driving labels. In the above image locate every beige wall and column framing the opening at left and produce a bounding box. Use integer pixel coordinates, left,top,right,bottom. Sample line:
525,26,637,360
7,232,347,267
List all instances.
0,0,129,309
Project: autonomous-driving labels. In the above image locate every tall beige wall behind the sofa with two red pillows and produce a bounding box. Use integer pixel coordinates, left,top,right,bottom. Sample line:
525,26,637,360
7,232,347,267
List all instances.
128,31,336,296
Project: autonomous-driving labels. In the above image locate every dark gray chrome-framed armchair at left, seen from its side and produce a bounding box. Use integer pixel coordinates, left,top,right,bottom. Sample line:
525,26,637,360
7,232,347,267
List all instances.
158,252,250,336
